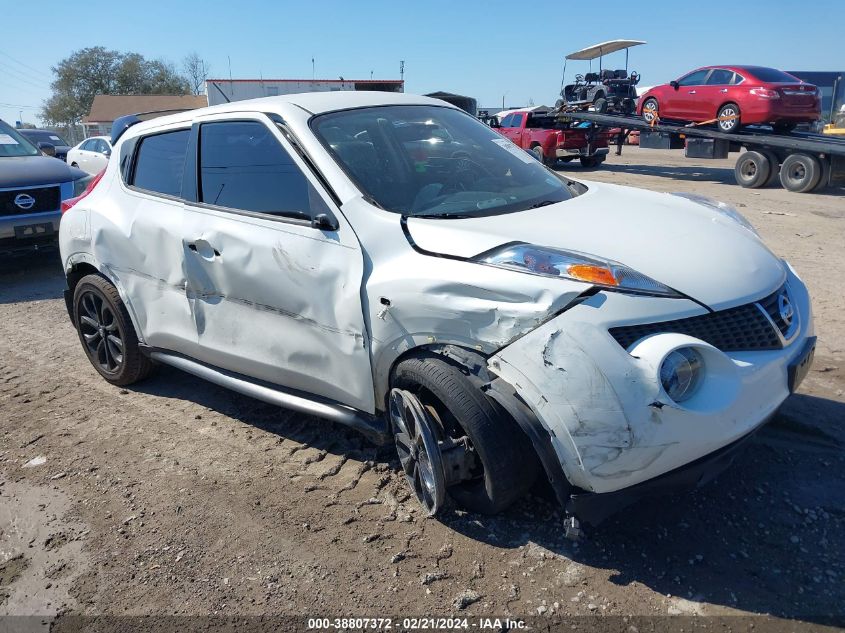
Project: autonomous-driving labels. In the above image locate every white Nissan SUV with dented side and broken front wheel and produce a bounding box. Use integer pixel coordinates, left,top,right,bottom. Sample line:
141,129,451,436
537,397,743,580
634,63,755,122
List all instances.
60,92,815,526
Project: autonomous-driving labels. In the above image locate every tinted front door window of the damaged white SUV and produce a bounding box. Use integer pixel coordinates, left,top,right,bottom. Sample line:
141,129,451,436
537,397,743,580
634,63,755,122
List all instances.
199,121,318,219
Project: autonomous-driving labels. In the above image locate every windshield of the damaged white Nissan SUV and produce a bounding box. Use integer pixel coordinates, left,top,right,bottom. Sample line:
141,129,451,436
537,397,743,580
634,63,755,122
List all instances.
312,106,577,217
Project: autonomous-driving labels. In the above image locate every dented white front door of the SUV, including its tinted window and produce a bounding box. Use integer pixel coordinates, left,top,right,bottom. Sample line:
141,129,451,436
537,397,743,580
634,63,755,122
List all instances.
182,113,374,411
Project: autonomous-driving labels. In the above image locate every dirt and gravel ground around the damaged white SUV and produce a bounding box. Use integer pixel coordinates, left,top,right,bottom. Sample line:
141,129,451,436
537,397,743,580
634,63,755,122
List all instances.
0,148,845,630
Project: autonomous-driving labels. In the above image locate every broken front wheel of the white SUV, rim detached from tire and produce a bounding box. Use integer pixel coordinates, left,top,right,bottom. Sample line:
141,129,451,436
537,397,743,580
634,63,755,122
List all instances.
388,352,539,515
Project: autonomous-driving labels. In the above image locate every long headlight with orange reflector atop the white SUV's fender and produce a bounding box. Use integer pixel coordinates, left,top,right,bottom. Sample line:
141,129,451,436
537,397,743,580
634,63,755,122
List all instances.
476,244,681,297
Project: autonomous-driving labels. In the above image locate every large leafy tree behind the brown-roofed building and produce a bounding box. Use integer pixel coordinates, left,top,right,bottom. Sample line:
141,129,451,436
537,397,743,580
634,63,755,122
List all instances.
41,46,190,126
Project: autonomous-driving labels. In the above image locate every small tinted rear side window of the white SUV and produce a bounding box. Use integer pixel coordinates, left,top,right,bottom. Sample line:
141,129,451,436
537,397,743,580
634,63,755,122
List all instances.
132,130,191,196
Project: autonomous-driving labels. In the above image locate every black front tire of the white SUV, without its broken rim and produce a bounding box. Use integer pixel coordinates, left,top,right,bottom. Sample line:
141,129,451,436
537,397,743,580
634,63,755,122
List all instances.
391,352,539,514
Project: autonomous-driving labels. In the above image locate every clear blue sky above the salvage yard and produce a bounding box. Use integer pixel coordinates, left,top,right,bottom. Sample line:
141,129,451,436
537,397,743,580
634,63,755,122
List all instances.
0,0,845,124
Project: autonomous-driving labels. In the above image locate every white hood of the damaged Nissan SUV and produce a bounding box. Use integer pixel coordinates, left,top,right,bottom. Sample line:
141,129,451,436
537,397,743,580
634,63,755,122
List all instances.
407,182,786,309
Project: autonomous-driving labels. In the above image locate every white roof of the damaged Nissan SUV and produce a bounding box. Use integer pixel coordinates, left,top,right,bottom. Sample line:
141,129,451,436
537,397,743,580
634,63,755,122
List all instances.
121,90,460,138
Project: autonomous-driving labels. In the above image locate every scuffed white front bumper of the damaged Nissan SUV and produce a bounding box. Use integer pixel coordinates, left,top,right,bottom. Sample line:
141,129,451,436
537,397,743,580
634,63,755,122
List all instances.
489,272,814,522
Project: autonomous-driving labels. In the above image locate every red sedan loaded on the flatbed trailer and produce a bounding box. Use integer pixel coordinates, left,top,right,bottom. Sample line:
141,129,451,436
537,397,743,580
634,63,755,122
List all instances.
637,66,821,132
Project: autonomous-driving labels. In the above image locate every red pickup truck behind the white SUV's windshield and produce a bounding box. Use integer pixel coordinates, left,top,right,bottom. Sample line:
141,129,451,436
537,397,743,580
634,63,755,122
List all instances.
493,110,610,167
